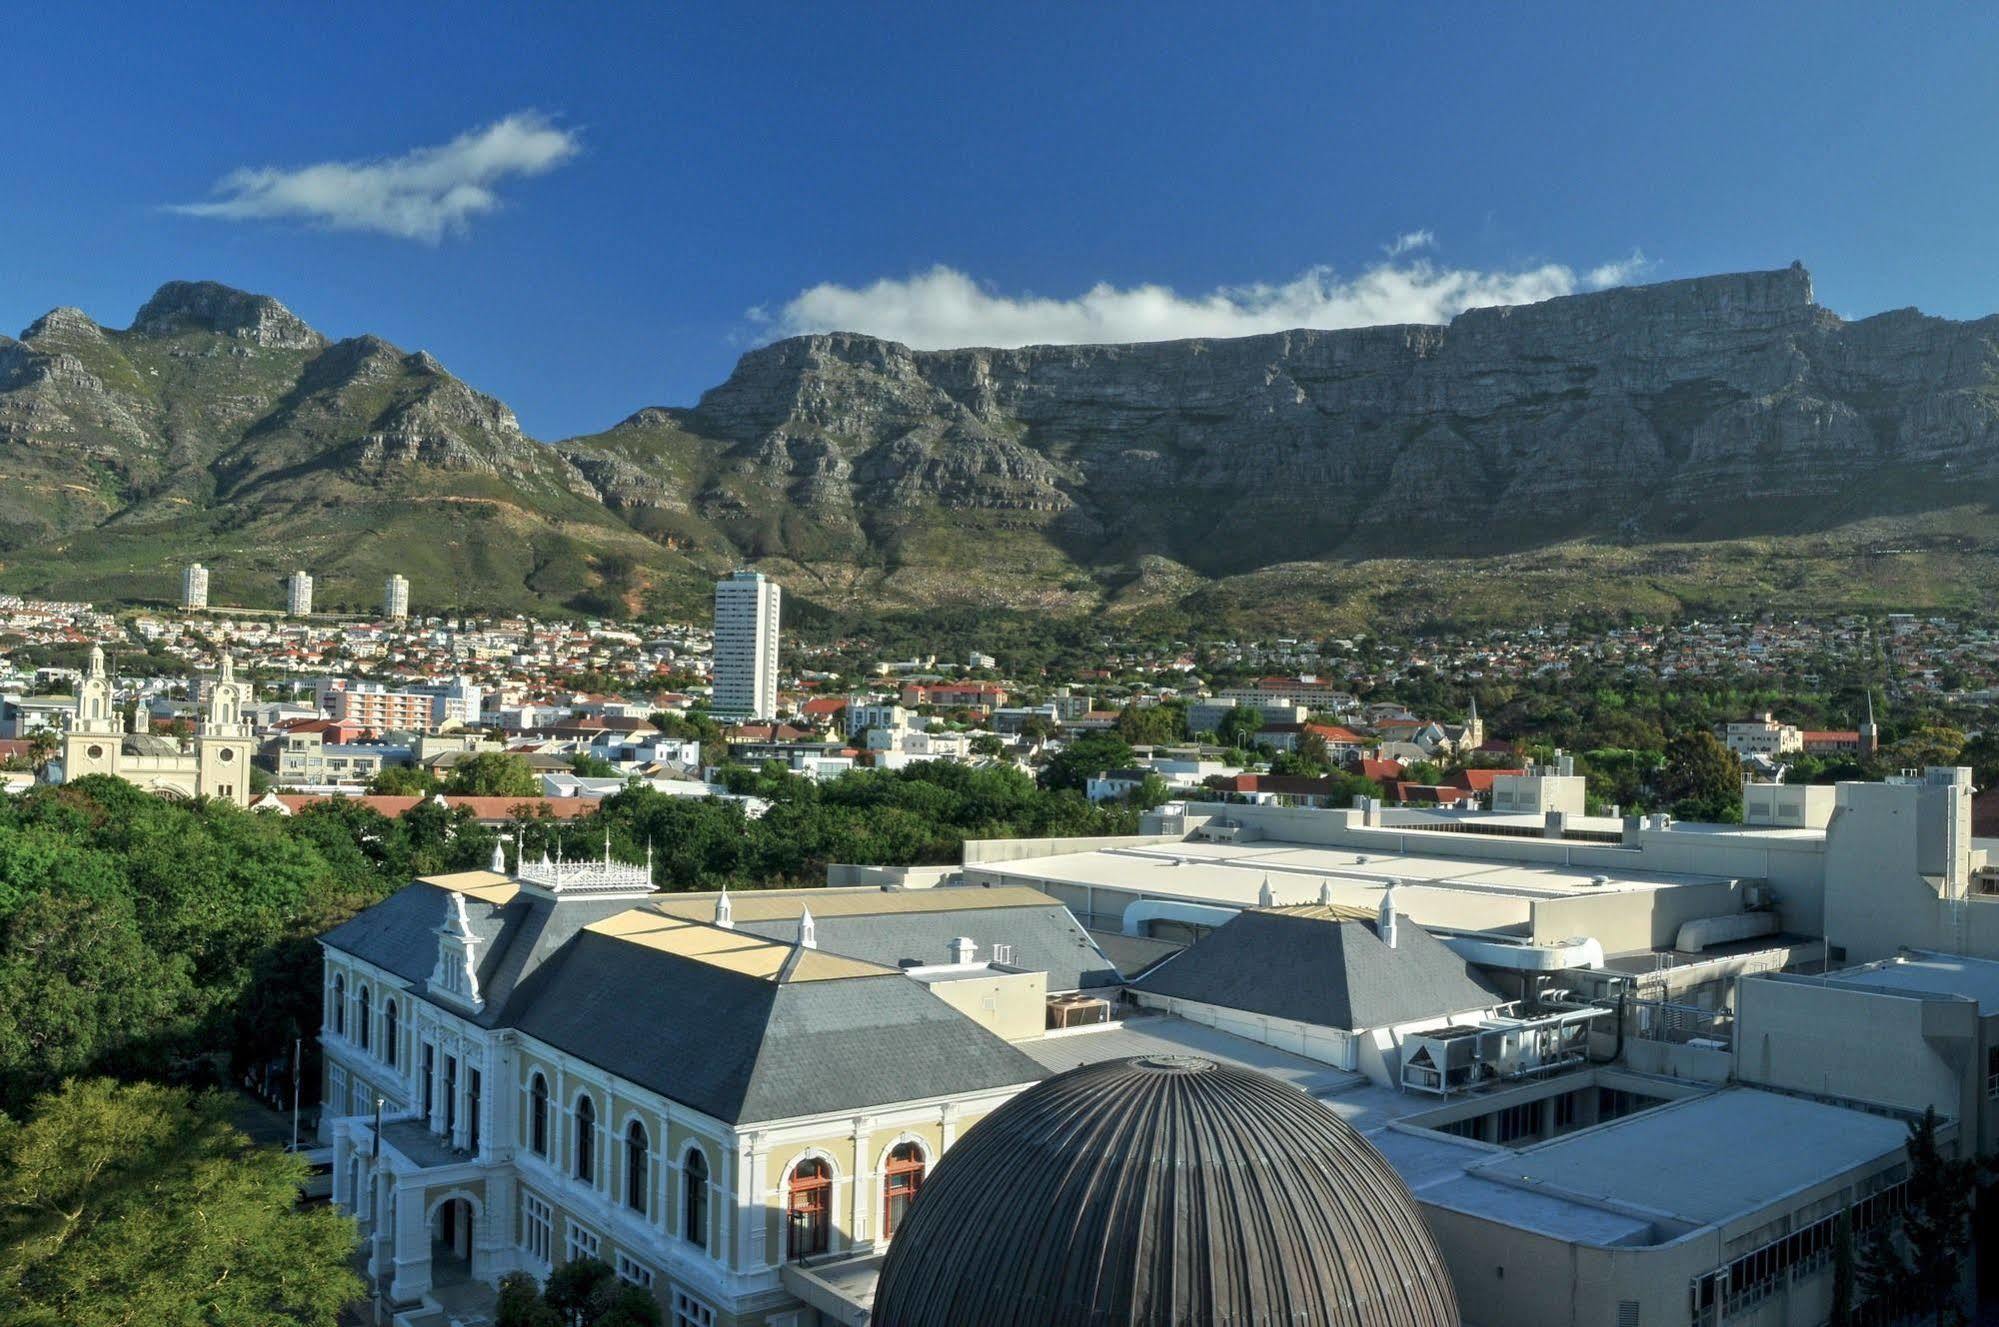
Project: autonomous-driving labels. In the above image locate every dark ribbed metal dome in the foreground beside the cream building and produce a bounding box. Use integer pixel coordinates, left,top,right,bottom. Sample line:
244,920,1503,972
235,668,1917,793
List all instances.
874,1055,1457,1327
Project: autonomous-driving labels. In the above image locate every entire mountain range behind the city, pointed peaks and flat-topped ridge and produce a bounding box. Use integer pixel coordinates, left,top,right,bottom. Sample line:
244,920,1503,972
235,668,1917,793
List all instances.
0,264,1999,618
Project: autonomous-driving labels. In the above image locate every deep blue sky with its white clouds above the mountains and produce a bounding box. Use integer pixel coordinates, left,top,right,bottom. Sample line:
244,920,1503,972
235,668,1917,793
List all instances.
0,4,1999,438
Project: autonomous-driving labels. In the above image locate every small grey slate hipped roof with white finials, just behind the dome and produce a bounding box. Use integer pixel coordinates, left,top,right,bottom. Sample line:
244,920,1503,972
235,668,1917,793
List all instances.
1133,907,1505,1031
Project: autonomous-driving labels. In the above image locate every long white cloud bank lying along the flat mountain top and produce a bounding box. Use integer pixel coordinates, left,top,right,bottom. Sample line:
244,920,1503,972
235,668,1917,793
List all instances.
752,245,1643,350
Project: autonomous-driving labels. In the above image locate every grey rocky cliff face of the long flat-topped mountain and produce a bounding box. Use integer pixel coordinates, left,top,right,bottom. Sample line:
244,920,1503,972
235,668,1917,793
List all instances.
679,266,1999,572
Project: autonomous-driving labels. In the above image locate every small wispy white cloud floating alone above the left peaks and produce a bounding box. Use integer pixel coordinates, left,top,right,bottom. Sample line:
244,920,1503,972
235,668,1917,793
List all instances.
170,110,580,244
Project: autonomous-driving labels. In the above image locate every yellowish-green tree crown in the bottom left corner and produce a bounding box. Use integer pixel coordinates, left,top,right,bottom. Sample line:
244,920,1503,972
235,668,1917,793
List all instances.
0,1079,362,1327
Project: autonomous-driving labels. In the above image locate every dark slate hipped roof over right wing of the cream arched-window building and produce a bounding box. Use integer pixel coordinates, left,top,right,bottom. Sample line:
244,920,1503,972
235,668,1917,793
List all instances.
518,931,1045,1123
